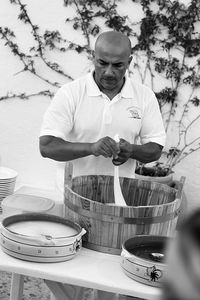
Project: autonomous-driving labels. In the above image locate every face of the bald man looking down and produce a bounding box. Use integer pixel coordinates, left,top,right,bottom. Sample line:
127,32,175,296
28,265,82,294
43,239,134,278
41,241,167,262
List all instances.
94,46,131,92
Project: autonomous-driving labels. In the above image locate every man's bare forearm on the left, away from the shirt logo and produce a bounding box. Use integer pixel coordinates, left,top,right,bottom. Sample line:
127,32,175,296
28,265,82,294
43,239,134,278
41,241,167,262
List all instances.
40,137,92,161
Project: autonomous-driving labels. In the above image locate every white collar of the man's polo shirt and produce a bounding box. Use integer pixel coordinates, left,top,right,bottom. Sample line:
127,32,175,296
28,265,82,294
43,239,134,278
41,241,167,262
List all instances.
86,70,132,98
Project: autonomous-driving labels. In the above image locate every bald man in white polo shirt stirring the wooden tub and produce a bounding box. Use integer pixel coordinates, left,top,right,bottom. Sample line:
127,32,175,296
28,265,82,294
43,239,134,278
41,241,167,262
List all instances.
40,31,165,300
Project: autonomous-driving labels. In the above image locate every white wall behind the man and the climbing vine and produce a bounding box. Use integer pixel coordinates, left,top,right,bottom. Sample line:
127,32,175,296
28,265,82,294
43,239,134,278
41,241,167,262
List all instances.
0,0,200,208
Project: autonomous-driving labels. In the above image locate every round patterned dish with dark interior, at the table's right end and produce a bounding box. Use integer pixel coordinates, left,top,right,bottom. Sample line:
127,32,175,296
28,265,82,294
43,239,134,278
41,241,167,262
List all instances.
121,235,170,287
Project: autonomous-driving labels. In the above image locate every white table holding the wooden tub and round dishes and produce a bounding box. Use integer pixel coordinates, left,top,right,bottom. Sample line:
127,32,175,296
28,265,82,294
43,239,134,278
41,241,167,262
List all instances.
0,185,161,300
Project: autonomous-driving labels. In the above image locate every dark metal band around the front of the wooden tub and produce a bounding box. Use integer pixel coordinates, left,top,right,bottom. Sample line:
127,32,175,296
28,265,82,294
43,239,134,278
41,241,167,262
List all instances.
65,200,180,225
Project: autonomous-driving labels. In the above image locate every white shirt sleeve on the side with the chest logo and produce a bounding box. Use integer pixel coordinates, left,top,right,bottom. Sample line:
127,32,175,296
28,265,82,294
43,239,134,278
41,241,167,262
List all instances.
140,94,166,146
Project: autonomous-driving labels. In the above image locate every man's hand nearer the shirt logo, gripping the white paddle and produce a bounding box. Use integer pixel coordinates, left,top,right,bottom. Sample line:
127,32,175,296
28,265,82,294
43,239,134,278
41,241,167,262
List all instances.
112,139,132,166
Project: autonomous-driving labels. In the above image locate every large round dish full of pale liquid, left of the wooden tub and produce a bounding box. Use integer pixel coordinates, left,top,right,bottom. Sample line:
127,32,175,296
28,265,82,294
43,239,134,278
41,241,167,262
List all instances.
0,213,85,262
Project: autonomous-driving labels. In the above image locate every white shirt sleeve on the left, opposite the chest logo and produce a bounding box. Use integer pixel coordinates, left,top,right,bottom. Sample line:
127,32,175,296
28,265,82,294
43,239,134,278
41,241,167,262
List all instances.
40,87,75,140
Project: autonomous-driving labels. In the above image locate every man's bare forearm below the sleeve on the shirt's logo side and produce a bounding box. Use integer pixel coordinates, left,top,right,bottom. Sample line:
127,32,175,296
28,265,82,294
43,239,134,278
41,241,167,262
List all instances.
131,142,163,163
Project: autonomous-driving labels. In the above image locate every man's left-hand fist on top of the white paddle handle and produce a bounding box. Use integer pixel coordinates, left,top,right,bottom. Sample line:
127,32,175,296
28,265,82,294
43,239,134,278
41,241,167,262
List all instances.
91,136,120,158
